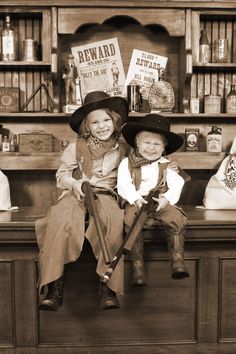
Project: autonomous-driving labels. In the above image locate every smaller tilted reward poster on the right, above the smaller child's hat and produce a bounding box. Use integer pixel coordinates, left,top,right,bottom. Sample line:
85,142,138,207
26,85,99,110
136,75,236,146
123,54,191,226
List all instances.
124,49,168,99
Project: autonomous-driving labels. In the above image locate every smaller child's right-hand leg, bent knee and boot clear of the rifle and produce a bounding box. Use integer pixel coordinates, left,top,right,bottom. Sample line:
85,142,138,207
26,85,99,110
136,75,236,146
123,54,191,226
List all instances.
159,205,189,279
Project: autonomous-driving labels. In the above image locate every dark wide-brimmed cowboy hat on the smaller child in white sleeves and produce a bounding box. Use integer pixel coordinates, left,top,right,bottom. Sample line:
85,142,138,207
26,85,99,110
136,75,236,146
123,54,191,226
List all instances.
122,114,184,155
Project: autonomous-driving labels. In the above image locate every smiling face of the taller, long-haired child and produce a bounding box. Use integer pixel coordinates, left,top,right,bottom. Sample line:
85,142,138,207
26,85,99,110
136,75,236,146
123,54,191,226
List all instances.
87,109,115,141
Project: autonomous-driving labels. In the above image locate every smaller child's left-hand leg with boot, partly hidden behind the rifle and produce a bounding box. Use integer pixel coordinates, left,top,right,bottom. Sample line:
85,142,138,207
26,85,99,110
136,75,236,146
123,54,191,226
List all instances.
124,205,146,286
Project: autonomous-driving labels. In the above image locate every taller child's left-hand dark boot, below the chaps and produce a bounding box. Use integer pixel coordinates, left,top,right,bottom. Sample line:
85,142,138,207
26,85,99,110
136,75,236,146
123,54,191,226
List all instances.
39,274,64,311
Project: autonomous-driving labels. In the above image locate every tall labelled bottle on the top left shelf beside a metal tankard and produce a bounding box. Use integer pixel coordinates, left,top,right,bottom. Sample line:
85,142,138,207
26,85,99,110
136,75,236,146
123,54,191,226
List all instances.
1,16,16,61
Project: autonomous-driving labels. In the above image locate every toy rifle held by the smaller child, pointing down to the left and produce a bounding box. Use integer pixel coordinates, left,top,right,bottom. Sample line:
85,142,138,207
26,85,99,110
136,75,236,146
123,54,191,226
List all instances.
100,168,191,283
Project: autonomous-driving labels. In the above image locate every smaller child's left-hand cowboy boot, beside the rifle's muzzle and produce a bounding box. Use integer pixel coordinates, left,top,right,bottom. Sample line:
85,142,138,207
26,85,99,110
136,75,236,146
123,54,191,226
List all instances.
130,237,147,286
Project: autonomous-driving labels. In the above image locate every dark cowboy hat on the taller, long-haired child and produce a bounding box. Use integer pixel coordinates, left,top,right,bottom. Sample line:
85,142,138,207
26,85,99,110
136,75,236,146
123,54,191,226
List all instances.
69,91,129,133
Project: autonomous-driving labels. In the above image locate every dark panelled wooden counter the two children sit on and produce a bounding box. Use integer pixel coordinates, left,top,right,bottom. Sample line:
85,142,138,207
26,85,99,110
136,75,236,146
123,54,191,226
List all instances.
0,207,236,354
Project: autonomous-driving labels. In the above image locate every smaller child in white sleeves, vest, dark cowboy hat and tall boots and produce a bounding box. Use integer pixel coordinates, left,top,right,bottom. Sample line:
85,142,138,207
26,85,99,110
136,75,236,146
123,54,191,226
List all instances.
117,114,189,285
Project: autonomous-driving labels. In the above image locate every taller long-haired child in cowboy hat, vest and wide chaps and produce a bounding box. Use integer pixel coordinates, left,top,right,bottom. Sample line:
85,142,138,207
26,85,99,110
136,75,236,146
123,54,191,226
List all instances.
36,91,128,310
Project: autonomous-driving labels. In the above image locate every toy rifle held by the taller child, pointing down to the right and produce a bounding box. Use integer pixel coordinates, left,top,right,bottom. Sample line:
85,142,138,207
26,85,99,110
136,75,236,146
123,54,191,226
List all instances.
82,181,111,264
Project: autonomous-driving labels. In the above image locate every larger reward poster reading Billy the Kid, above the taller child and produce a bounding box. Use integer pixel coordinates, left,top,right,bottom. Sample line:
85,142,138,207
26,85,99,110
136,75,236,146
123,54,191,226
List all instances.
71,38,125,98
